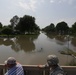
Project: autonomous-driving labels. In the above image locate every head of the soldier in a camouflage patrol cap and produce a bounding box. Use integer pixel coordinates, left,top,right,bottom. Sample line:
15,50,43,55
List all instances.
47,55,59,66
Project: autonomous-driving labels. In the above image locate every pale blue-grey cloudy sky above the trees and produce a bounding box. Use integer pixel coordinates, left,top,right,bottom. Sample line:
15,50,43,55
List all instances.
0,0,76,28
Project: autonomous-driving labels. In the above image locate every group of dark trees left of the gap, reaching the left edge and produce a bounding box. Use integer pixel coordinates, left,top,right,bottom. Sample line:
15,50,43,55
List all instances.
0,15,40,35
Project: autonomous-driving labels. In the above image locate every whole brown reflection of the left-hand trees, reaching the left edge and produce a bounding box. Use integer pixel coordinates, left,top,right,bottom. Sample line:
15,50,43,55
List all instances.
0,35,39,52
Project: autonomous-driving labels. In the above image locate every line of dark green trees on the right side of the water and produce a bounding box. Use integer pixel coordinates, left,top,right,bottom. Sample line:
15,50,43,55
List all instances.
42,21,76,35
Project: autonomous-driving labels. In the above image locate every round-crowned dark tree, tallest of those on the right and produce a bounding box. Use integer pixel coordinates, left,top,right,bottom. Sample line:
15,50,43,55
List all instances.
56,21,69,34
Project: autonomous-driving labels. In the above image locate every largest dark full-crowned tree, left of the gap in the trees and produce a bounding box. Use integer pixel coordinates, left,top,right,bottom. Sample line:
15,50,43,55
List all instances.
16,15,38,33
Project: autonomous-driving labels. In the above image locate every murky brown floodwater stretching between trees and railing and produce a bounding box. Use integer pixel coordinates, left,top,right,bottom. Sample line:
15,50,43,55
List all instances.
0,33,76,65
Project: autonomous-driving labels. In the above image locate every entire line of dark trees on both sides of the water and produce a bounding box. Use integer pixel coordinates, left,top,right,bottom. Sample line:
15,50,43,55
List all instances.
0,15,76,35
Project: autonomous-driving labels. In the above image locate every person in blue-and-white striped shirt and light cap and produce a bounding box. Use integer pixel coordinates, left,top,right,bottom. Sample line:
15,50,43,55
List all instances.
4,57,24,75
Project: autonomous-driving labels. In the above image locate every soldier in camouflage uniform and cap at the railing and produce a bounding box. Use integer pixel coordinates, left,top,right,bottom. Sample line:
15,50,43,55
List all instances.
46,55,65,75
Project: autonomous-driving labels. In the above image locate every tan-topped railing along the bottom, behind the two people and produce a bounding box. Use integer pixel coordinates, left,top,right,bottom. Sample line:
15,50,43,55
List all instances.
0,64,76,75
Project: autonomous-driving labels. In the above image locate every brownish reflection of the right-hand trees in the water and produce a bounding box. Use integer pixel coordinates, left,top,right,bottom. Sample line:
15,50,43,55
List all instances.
47,35,76,46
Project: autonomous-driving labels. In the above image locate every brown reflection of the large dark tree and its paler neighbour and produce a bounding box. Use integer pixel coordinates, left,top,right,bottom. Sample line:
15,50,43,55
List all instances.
11,35,38,52
